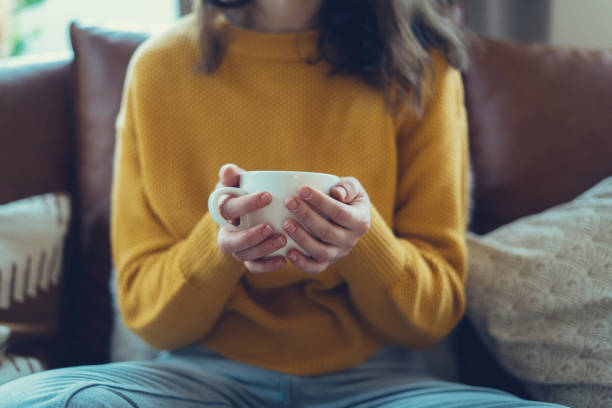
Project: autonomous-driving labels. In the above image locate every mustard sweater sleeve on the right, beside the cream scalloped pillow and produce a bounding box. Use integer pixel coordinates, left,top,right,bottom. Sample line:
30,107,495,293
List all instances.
340,56,469,348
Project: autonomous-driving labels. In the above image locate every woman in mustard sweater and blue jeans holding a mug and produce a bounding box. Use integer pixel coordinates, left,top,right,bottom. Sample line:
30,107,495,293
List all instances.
0,0,568,408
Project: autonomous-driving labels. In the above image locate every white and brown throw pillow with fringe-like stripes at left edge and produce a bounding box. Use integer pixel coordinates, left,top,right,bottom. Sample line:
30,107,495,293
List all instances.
0,194,70,384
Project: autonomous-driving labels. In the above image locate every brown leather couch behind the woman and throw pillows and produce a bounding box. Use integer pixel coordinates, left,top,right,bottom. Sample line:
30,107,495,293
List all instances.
0,20,612,395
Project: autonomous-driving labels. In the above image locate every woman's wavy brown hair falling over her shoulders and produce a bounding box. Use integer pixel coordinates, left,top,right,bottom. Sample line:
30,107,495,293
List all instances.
194,0,468,111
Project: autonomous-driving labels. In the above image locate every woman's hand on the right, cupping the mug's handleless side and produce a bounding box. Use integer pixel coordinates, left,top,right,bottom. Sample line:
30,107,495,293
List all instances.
283,177,370,274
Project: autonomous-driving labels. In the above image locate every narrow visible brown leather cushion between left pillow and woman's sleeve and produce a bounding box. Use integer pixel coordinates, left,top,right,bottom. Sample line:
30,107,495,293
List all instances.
70,23,147,364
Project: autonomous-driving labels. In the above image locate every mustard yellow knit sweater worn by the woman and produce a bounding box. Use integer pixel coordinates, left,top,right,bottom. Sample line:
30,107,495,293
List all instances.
111,16,468,375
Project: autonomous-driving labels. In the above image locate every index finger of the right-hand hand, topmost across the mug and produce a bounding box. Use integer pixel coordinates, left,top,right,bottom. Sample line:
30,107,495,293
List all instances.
296,187,367,231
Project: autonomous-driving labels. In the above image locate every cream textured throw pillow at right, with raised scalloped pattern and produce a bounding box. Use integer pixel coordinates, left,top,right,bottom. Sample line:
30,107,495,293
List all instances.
467,178,612,408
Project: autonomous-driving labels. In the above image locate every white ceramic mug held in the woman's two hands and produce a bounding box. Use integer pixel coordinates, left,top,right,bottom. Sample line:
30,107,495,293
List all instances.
208,171,340,257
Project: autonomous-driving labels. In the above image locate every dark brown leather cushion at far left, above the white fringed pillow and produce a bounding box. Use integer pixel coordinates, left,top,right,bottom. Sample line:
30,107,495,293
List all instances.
0,58,72,204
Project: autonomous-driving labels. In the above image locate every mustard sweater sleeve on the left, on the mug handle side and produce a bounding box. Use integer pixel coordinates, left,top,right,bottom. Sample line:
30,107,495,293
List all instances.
111,63,243,349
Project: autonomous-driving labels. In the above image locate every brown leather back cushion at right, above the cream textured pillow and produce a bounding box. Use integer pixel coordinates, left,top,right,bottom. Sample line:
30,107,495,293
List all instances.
465,39,612,233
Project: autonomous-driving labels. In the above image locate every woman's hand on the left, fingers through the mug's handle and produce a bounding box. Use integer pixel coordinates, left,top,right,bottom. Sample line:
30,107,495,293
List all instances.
216,164,287,273
